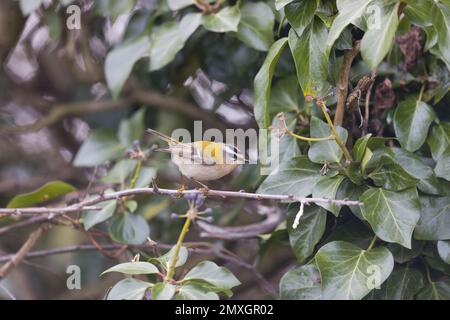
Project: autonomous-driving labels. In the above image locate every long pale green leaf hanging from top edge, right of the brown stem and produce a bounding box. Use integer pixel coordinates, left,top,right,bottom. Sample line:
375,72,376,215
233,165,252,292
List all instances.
361,0,400,69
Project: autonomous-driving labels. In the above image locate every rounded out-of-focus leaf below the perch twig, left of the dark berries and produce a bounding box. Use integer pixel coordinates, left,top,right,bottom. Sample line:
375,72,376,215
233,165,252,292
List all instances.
109,213,150,244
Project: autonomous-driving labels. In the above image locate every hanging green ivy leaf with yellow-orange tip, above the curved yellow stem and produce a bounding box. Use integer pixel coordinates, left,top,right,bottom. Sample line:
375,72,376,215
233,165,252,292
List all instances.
289,17,329,98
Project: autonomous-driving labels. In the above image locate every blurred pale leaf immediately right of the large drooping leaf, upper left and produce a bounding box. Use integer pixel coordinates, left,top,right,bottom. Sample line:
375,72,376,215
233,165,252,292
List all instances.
150,21,184,71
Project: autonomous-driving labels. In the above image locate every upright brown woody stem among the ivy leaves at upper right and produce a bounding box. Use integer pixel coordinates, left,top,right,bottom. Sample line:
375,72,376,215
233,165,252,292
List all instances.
334,41,361,126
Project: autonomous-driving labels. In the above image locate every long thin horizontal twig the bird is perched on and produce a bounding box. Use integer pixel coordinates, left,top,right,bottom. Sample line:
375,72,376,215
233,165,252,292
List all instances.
0,188,362,215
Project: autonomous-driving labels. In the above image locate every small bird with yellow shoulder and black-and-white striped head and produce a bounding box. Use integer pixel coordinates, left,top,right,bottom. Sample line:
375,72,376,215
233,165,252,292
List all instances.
147,129,246,189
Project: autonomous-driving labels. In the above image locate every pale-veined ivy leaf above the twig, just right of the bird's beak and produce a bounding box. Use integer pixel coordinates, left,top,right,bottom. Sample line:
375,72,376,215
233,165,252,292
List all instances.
257,156,322,197
